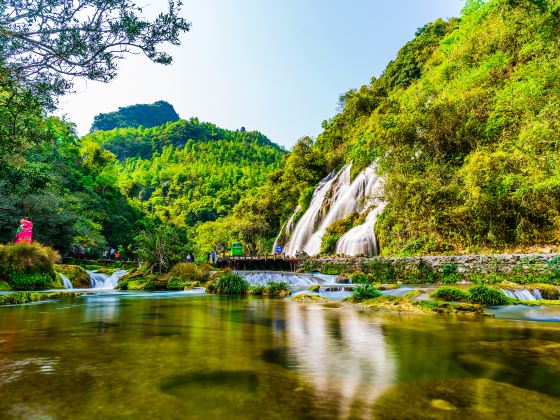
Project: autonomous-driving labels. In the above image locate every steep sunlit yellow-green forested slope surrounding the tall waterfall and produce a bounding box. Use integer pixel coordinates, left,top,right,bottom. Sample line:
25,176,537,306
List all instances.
218,0,560,255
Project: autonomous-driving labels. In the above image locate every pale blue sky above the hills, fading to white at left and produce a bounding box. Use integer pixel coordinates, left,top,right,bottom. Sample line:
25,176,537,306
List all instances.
60,0,464,148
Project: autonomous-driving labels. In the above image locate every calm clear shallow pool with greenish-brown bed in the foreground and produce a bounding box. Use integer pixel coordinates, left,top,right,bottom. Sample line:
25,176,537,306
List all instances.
0,292,560,419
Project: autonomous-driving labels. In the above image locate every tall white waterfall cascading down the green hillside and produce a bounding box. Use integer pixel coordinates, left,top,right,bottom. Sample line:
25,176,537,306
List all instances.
284,164,384,256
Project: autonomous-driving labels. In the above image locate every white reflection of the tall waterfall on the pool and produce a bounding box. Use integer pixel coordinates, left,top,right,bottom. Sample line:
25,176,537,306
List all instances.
286,305,396,416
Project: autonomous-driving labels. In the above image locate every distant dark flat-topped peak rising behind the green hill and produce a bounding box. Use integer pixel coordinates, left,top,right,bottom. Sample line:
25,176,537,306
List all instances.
90,101,179,132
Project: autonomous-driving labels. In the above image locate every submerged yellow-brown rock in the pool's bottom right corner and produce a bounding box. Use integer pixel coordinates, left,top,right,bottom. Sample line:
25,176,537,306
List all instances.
372,379,560,419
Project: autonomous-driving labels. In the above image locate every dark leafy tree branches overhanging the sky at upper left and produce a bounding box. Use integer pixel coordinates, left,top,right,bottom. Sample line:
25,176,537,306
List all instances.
0,0,190,105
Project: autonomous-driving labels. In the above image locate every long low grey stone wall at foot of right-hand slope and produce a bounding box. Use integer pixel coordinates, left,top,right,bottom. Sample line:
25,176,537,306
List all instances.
299,254,560,278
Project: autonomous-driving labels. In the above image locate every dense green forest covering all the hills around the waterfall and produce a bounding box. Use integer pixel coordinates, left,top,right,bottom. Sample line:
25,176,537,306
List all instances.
0,0,560,255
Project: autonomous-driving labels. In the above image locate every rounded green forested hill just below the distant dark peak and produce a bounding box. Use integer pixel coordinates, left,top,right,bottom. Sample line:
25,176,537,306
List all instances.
82,118,285,230
